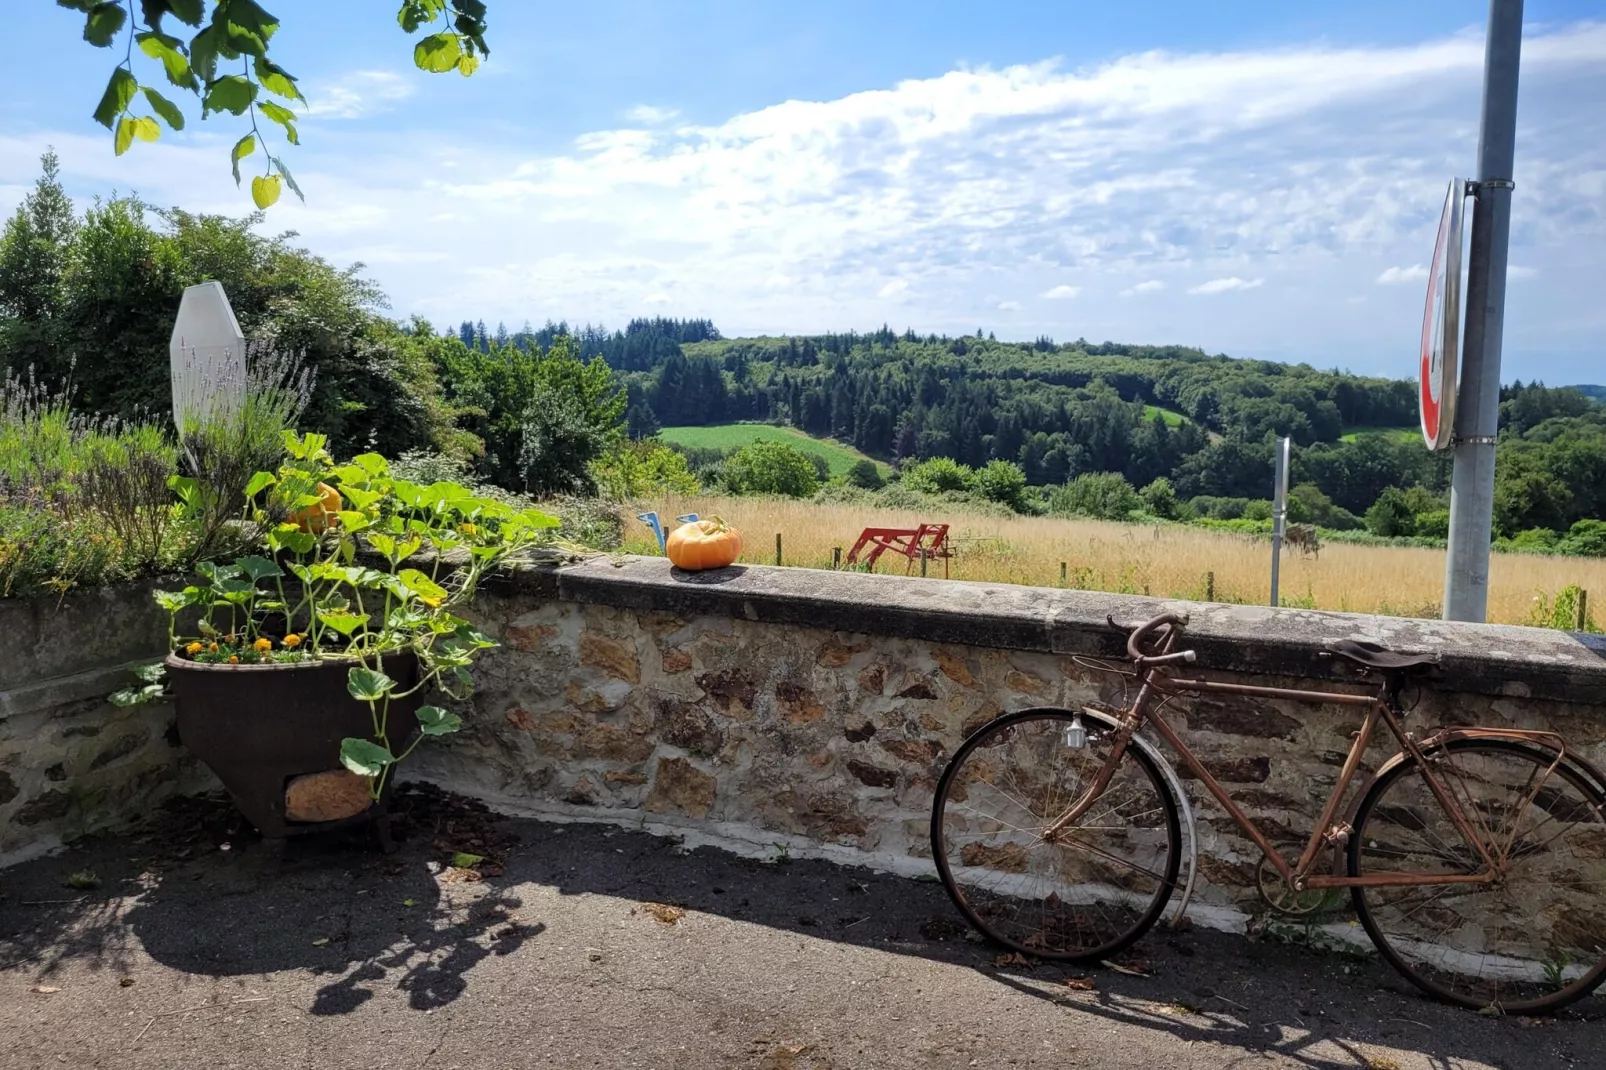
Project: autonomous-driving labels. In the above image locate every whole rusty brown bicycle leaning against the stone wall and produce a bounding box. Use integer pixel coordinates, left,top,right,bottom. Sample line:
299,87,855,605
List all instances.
931,614,1606,1014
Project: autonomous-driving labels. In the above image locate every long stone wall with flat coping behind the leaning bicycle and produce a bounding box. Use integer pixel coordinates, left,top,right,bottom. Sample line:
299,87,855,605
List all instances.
414,559,1606,924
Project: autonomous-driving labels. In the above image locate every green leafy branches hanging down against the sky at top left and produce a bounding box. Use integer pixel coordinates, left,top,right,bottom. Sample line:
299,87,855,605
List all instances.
56,0,490,209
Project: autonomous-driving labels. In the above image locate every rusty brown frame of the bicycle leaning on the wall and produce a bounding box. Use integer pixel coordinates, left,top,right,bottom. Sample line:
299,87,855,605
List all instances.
1042,628,1569,892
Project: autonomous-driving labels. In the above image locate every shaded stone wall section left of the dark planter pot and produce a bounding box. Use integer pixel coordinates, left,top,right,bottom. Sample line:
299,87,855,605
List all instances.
0,586,210,864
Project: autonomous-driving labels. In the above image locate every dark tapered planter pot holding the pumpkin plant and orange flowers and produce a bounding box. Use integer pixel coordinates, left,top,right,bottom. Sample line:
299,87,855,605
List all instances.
167,654,422,839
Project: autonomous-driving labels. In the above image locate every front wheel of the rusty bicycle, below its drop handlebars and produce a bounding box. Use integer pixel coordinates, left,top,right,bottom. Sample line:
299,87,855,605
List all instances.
931,709,1182,959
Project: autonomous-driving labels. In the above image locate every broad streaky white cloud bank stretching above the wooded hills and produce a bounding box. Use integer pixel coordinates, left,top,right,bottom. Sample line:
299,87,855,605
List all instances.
0,22,1606,381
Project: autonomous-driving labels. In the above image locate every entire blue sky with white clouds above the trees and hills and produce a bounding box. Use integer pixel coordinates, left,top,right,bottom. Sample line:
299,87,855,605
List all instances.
0,0,1606,384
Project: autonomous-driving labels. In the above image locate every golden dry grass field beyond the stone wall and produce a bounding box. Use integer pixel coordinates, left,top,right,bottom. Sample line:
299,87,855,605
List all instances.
625,496,1606,623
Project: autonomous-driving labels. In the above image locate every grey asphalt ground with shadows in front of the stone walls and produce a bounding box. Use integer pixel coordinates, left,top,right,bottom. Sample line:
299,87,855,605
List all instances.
0,794,1606,1070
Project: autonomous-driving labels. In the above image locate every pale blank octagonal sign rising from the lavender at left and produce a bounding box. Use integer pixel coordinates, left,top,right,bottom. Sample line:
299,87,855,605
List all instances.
167,281,246,432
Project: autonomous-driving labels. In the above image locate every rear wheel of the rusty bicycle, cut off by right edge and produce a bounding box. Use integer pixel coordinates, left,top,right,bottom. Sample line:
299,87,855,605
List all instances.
1349,739,1606,1014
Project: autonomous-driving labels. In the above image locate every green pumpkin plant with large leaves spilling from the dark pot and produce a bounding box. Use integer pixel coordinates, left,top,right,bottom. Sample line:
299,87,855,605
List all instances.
112,432,559,798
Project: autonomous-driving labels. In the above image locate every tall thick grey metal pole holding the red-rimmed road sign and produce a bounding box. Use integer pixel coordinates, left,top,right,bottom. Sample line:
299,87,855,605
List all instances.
1444,0,1522,620
